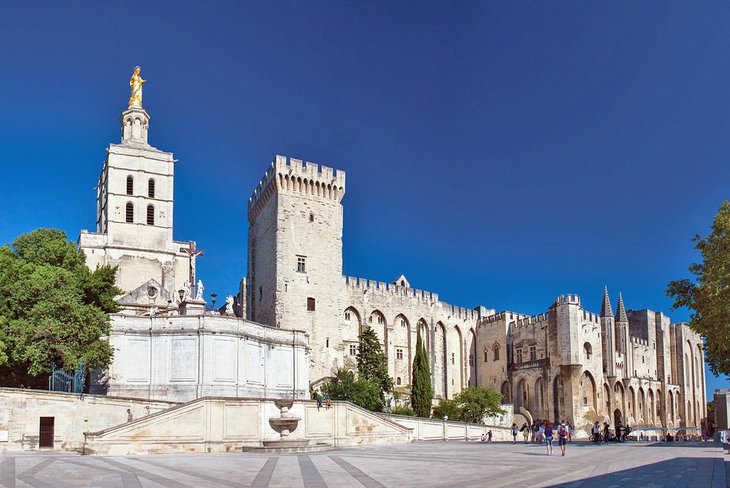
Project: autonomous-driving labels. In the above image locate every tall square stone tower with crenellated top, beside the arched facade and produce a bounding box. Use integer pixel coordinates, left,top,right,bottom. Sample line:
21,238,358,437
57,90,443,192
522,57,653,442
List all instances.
246,156,345,381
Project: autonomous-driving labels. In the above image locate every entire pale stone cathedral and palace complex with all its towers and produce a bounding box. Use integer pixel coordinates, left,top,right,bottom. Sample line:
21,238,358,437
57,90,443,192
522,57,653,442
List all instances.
79,67,706,428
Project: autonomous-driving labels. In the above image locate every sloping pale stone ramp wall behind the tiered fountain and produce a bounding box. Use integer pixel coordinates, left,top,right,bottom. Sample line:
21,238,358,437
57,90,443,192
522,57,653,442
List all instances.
85,397,412,455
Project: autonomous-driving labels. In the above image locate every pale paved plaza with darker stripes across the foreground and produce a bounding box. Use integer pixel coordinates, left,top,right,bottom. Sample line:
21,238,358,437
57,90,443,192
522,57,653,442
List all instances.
0,441,730,488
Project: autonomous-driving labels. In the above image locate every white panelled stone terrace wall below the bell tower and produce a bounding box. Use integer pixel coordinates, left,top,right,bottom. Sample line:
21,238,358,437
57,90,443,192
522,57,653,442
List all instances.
101,314,309,402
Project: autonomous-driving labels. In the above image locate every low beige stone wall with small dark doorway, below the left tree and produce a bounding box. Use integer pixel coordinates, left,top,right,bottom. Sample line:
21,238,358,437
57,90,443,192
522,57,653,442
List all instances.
0,388,177,452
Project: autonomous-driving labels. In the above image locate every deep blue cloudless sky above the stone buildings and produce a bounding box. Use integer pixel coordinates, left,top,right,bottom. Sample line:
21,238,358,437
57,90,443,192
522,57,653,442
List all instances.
0,1,730,392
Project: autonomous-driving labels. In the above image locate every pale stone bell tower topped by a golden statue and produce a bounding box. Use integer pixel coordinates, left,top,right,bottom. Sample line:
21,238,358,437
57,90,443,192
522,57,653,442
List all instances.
79,67,194,314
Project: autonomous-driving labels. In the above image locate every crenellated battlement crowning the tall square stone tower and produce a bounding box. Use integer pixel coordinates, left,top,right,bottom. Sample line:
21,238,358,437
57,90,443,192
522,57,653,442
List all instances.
248,155,345,220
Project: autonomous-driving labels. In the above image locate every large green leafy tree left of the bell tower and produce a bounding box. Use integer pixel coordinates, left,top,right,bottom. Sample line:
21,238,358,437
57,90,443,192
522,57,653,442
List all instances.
0,229,121,387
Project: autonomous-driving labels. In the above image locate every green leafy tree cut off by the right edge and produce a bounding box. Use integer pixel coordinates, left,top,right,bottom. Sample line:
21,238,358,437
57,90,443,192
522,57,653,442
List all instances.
667,201,730,376
